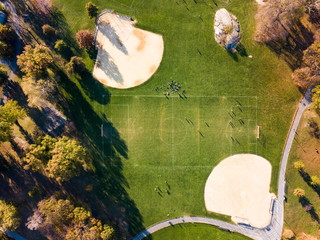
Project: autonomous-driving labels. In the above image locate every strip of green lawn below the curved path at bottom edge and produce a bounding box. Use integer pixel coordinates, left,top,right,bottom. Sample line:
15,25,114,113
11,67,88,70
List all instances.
152,223,249,240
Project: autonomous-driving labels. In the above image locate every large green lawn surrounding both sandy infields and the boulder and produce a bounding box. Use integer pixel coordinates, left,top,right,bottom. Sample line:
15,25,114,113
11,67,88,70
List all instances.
54,0,299,239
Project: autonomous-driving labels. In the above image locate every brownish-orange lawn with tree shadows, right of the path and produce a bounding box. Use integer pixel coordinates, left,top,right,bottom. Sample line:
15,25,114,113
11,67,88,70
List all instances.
285,110,320,236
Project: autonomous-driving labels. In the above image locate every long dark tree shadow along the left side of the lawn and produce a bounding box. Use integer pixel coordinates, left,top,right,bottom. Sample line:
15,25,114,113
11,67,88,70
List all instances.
58,71,144,239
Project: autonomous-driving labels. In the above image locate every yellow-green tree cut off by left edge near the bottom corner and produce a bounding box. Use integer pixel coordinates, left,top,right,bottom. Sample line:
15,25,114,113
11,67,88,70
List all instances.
0,200,20,231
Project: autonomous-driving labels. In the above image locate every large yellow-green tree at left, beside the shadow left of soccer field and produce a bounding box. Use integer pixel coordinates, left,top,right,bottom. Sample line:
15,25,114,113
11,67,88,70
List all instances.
46,137,90,181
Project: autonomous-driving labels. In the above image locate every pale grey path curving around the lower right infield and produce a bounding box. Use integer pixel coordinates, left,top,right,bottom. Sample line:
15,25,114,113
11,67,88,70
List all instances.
133,88,311,240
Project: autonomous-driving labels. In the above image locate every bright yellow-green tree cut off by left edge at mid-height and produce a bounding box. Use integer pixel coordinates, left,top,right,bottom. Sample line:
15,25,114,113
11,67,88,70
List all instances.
0,100,26,142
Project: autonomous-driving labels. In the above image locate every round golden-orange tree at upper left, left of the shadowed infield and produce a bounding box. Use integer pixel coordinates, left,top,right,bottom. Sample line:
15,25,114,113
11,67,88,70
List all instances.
17,45,53,76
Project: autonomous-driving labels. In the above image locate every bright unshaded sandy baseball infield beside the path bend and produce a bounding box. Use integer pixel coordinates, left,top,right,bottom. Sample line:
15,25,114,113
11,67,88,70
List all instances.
204,154,275,228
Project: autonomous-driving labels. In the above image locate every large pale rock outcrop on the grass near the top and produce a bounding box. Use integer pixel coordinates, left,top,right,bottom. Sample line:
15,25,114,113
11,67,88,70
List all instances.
214,8,241,50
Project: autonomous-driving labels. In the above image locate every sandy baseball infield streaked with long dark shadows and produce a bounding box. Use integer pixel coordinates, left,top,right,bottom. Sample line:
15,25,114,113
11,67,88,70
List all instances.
93,11,164,89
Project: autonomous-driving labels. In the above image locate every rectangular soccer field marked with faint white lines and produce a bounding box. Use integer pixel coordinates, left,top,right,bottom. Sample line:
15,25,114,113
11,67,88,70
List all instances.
102,95,258,168
